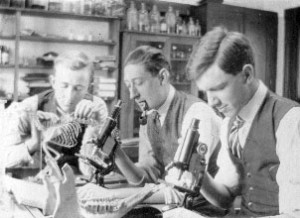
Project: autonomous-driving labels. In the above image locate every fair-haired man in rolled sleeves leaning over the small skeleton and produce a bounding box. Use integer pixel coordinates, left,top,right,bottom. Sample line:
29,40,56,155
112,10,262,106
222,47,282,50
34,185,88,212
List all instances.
1,51,107,174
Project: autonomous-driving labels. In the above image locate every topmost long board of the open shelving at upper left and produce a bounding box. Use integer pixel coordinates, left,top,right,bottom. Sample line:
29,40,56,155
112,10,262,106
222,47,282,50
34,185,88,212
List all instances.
0,6,121,21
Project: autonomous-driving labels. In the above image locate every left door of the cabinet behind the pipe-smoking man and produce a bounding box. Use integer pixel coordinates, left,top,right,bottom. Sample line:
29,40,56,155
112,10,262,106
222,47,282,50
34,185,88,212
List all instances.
120,32,169,138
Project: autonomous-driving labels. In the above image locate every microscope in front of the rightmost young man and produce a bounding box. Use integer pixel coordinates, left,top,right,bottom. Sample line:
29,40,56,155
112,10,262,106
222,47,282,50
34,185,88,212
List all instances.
160,118,207,208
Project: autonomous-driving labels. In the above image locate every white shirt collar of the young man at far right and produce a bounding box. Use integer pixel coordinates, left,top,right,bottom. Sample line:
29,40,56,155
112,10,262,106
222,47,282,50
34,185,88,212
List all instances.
239,81,268,122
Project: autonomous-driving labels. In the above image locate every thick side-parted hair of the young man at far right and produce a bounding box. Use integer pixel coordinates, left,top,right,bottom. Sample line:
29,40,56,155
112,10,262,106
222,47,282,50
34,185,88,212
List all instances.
187,27,255,79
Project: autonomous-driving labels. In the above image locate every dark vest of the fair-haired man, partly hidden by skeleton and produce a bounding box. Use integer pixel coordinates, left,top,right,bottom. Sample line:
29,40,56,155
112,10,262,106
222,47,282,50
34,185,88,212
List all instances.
37,89,92,169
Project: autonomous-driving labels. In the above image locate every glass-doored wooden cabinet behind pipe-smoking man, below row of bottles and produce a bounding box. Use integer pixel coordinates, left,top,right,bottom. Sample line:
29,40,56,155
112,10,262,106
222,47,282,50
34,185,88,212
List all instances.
119,31,199,138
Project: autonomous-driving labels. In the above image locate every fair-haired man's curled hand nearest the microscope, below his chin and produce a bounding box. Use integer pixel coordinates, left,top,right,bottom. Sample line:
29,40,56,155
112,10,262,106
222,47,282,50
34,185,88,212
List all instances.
74,99,96,119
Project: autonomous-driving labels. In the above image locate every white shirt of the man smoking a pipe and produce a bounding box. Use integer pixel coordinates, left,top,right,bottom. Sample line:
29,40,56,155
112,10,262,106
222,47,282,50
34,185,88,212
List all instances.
136,86,222,182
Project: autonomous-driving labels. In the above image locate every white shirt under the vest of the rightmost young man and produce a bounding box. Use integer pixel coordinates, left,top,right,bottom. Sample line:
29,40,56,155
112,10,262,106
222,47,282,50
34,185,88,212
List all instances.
216,81,300,213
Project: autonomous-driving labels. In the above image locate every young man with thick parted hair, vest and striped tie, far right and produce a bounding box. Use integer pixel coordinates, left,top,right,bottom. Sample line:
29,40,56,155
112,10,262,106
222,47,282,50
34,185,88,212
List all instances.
188,28,300,216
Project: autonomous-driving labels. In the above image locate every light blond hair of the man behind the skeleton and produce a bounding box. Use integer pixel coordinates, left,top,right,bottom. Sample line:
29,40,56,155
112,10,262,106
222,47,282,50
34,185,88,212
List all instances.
54,51,93,72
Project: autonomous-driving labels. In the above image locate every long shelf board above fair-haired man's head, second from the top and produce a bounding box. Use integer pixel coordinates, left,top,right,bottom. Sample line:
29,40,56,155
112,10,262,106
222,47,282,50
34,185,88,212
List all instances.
20,36,116,46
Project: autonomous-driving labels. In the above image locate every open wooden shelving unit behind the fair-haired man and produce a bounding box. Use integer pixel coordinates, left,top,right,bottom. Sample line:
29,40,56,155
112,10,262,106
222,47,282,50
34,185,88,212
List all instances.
0,7,120,107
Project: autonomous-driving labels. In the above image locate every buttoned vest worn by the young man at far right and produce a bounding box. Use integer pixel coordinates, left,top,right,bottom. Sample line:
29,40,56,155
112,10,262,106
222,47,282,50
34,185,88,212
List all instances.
241,92,298,216
